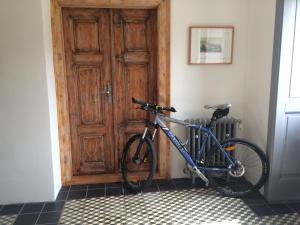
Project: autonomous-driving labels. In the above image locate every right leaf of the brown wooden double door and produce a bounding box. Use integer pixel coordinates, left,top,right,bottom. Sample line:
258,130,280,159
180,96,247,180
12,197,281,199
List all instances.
112,9,157,169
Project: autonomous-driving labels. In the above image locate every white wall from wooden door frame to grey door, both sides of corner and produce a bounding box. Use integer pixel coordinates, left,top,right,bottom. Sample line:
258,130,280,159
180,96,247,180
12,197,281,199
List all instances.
171,0,275,177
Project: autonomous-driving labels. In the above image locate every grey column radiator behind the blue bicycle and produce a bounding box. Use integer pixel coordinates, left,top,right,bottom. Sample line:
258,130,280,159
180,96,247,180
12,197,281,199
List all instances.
185,118,241,180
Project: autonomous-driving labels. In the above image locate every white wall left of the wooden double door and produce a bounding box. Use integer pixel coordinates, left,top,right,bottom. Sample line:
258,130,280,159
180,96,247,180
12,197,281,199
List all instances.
0,0,61,204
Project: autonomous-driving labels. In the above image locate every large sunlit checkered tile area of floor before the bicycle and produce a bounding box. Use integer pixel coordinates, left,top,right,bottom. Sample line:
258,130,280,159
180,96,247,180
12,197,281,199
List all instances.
60,189,300,225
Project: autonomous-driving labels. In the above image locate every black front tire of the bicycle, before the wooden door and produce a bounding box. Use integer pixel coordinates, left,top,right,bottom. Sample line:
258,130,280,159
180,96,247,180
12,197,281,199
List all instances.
121,134,157,193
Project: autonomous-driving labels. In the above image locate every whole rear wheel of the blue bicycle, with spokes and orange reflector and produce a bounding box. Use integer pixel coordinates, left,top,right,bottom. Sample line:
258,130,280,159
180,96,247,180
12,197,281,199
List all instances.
206,138,269,197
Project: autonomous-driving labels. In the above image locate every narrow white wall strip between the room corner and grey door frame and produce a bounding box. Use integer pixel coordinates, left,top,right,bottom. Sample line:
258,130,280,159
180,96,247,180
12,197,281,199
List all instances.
244,0,276,150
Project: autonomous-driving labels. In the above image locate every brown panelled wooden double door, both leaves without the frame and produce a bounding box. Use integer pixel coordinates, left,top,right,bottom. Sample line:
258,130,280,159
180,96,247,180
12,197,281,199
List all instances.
62,8,157,176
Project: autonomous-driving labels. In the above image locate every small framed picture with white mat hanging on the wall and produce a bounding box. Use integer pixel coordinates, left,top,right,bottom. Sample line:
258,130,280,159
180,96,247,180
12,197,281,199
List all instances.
189,27,234,65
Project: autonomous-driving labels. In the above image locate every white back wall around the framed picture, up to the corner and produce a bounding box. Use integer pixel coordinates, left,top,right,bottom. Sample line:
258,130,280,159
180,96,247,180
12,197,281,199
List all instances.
171,0,248,177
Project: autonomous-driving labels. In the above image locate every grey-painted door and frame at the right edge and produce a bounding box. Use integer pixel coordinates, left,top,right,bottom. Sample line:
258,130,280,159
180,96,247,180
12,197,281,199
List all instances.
265,0,300,201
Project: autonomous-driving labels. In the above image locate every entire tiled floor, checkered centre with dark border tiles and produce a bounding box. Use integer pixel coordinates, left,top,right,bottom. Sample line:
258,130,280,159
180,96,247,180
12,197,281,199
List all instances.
0,179,300,225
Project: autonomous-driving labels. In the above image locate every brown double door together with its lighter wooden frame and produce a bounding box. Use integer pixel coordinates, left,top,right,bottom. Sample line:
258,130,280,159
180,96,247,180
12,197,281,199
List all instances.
52,0,169,184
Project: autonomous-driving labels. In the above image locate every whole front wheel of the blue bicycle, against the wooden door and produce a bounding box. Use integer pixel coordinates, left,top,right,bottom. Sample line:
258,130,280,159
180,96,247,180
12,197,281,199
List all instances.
121,134,157,193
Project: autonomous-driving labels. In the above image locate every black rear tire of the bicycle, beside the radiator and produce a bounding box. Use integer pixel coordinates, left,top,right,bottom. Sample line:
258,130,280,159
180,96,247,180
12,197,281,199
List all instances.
205,138,270,198
